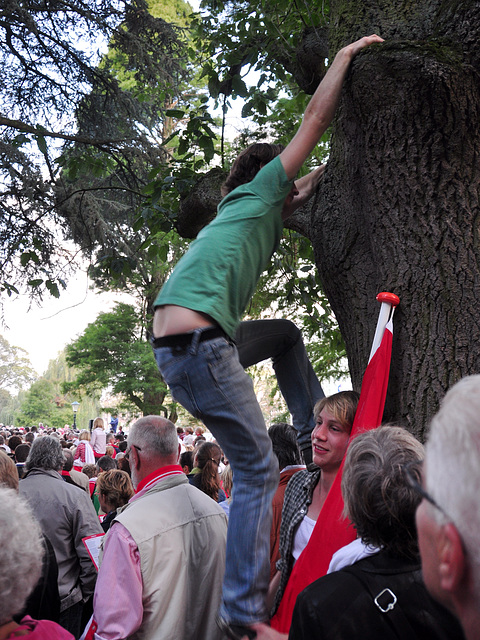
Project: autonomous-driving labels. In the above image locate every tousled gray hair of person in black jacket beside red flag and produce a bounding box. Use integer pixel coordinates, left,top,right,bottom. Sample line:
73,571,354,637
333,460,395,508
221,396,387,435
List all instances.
342,426,424,558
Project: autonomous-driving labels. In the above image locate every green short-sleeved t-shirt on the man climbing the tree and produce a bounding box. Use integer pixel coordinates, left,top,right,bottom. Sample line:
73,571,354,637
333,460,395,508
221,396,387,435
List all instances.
155,156,292,336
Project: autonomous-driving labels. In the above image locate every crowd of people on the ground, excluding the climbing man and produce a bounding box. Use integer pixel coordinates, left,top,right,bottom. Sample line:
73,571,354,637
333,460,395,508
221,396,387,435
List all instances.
0,384,480,640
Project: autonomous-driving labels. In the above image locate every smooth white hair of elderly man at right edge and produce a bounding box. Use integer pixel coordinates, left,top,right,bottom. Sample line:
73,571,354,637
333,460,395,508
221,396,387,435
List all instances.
425,375,480,602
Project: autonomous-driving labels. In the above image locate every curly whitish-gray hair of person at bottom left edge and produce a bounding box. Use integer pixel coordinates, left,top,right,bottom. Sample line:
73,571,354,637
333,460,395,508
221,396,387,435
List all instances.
0,487,43,625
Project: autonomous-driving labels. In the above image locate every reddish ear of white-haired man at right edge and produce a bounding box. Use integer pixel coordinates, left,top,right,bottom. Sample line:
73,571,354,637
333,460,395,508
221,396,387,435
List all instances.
437,522,467,594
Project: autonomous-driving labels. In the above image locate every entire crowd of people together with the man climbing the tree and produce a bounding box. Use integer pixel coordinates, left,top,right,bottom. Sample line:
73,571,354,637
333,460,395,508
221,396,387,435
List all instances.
0,35,480,640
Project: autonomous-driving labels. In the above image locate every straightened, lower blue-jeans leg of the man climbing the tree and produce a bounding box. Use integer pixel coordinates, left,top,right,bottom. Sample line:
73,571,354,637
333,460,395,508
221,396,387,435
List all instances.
155,329,278,625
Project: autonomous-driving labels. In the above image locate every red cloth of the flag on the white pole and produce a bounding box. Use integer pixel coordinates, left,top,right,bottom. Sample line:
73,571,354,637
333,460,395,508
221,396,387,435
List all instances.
271,320,393,633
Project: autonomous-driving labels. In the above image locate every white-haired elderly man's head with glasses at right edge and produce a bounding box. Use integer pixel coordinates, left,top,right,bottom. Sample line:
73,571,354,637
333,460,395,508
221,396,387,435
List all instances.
416,375,480,640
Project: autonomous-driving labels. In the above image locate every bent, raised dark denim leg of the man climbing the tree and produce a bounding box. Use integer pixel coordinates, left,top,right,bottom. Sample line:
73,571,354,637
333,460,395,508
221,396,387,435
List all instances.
235,319,325,449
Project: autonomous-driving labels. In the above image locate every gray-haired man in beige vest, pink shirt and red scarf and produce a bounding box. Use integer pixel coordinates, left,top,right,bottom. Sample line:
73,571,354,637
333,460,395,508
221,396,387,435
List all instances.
93,416,231,640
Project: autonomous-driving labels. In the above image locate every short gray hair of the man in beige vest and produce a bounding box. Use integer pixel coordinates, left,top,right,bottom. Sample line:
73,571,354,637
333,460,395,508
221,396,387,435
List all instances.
128,416,178,457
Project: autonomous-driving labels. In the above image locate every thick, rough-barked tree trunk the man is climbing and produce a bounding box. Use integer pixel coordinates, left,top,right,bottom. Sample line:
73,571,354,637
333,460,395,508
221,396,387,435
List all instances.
304,0,480,437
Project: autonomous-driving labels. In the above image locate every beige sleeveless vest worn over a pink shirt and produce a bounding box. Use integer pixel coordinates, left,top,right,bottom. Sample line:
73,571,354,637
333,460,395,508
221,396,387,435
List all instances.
115,475,227,640
